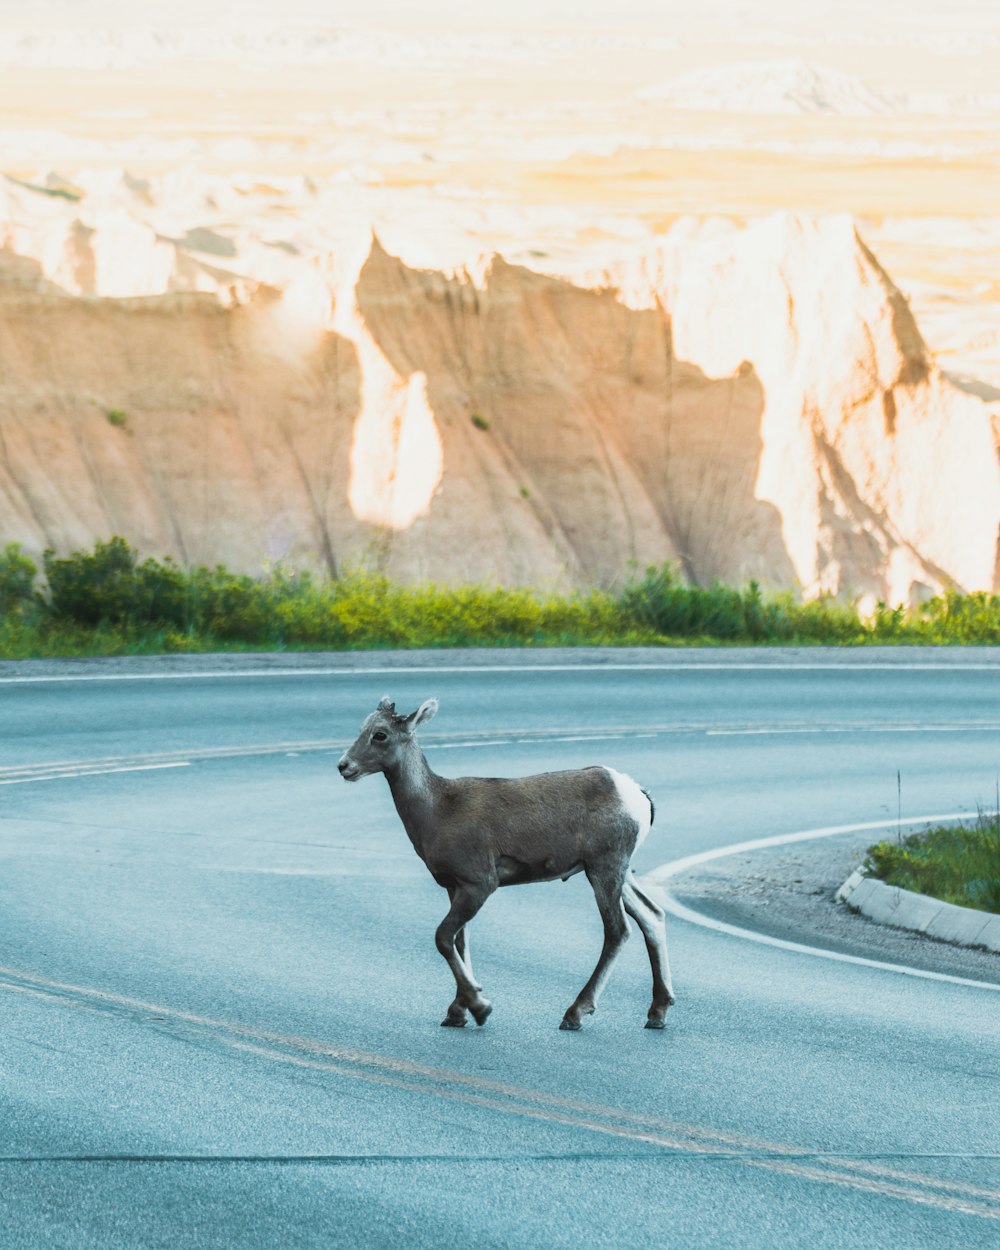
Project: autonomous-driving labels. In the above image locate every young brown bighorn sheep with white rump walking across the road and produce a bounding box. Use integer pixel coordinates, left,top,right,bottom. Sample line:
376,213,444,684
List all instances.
338,698,674,1031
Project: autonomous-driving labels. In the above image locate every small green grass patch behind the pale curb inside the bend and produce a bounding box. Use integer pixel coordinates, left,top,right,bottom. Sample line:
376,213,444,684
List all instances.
865,813,1000,913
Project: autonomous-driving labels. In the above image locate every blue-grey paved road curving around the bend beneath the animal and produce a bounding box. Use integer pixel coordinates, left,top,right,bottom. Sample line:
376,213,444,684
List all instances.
0,651,1000,1250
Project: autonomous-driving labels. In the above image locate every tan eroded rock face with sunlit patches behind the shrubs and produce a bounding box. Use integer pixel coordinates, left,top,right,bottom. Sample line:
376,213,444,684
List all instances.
0,218,1000,601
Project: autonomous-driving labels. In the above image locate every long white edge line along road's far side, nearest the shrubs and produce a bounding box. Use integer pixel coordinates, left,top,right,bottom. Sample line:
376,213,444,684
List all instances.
0,660,1000,685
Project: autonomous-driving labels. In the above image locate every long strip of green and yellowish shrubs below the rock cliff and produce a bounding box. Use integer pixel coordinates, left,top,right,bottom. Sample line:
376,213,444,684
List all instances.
0,538,1000,659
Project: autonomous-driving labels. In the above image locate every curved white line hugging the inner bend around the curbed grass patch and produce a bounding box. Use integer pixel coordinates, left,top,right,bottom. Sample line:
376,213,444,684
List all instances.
645,811,1000,993
